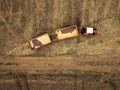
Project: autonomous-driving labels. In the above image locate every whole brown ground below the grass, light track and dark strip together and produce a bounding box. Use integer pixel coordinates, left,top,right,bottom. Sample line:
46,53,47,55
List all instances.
0,56,120,90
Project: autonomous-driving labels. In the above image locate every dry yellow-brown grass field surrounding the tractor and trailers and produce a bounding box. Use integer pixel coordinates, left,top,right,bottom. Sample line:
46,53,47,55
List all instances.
0,0,120,56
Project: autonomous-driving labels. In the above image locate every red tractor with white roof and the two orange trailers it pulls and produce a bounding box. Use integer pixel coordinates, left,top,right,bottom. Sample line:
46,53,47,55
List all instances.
29,25,99,49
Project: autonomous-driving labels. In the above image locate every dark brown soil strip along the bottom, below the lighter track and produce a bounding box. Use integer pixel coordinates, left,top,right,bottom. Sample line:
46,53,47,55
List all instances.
0,71,120,90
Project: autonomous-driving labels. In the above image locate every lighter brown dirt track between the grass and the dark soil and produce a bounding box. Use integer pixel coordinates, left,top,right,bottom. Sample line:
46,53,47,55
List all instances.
0,57,120,72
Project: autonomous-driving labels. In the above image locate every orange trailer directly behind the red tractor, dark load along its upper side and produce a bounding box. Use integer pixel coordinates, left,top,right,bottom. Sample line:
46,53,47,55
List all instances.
55,25,79,40
